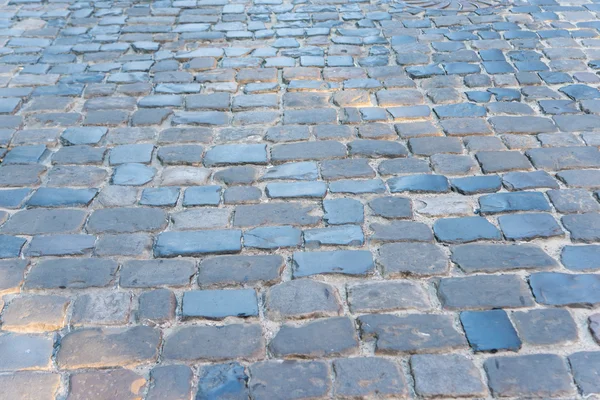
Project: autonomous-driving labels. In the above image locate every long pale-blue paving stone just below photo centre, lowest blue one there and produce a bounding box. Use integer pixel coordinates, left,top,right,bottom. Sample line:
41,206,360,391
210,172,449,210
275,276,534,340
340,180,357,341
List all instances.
292,250,375,278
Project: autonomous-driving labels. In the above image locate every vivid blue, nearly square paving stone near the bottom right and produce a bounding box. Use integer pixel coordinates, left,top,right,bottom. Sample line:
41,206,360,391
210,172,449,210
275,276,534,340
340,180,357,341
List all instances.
460,310,521,352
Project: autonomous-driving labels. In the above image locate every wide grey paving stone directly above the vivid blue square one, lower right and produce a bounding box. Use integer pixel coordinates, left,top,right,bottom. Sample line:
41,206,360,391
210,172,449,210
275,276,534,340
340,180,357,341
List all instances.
438,275,533,310
